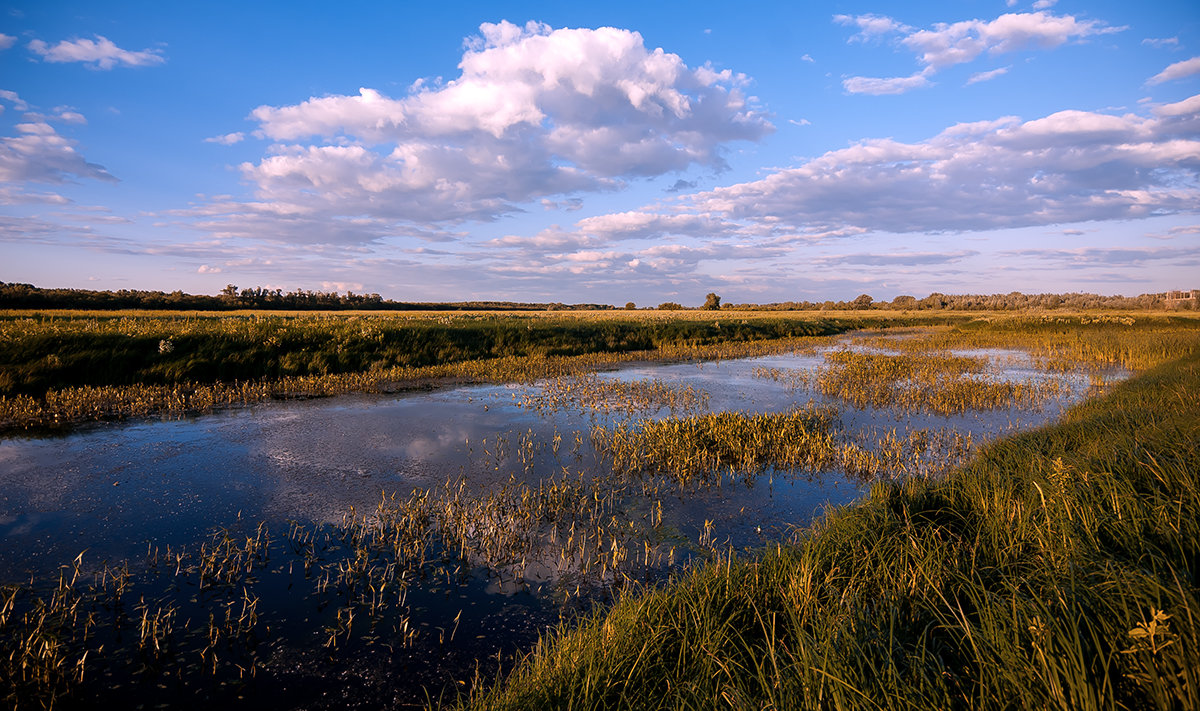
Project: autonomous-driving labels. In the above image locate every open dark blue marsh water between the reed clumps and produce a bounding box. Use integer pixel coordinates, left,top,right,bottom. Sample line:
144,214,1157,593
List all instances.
0,341,1116,707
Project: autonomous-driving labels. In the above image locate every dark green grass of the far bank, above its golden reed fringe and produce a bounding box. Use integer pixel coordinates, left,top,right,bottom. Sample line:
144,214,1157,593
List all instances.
0,313,883,396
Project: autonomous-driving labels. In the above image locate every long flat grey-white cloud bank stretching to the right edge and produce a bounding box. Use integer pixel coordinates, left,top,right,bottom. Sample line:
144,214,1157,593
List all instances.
549,95,1200,245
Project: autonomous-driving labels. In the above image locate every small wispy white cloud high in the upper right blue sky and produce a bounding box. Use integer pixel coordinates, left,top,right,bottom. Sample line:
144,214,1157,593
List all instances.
834,12,1124,95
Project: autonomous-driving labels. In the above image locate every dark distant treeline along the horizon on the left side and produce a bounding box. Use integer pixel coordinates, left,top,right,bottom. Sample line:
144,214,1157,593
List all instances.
0,281,612,311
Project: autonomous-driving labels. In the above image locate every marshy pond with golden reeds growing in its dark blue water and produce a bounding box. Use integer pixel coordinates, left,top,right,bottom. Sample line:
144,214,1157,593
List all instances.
0,340,1123,707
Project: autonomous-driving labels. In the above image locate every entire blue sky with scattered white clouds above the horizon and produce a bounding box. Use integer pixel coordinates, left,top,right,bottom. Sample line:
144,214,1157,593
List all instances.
0,0,1200,305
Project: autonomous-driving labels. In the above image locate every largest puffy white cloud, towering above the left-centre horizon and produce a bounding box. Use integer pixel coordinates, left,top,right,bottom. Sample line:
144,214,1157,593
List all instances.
187,22,773,240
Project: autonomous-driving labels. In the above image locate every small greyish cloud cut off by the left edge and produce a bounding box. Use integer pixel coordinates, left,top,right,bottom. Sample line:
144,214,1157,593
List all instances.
0,114,116,183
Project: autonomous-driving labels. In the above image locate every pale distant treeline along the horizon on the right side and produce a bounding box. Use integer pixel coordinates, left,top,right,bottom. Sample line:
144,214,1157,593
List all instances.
725,291,1200,311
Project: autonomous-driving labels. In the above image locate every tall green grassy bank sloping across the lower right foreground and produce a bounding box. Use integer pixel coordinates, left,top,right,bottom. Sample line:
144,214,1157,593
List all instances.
467,348,1200,709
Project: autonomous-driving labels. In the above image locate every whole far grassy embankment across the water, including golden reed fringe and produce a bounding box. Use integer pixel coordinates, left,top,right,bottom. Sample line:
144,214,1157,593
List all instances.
0,311,964,430
